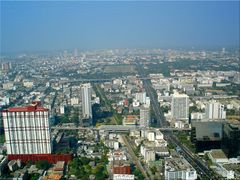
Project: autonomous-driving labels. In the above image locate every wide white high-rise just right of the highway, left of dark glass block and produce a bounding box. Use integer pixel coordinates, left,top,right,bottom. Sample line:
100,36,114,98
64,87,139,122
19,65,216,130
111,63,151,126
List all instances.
171,94,189,121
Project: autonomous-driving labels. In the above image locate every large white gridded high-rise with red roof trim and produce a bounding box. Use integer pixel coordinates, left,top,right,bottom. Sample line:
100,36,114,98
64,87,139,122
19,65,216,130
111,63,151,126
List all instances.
2,102,52,155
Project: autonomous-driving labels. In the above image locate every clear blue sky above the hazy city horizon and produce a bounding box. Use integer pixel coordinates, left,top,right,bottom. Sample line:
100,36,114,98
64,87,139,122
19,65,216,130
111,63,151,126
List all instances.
0,1,240,53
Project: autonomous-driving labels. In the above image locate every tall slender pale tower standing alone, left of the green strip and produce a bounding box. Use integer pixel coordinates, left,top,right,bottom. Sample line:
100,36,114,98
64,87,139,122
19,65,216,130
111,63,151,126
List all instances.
81,83,92,122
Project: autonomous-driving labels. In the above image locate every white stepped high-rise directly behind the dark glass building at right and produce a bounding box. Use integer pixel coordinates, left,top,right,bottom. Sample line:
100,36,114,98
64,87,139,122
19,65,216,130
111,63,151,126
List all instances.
205,101,226,120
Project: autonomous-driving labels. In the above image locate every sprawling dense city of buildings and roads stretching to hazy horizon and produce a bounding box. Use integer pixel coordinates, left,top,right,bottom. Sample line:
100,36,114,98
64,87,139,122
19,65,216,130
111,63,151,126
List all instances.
0,49,240,179
